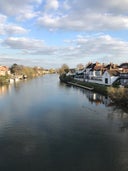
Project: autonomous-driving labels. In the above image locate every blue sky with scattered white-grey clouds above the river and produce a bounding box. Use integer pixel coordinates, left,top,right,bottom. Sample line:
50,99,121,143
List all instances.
0,0,128,68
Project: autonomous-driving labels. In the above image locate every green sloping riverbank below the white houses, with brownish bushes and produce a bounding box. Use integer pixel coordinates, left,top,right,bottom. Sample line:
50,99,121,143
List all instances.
60,75,128,106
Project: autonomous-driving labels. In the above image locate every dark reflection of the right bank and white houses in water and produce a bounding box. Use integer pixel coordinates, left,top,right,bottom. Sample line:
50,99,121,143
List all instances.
63,85,128,133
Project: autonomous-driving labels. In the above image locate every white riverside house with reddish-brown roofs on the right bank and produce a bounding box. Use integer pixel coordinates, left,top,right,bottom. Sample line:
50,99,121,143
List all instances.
74,62,120,85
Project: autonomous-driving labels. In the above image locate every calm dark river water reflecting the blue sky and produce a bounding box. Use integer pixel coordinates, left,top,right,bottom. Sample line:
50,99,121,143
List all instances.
0,75,128,171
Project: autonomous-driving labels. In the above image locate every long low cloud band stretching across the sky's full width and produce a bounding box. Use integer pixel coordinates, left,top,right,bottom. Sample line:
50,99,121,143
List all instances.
2,34,128,58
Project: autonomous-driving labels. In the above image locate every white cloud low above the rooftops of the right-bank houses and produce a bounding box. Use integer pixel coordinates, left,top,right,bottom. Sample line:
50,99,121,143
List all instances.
48,34,128,66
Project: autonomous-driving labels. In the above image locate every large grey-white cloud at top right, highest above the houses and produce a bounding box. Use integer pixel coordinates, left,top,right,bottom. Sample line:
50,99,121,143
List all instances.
38,0,128,31
